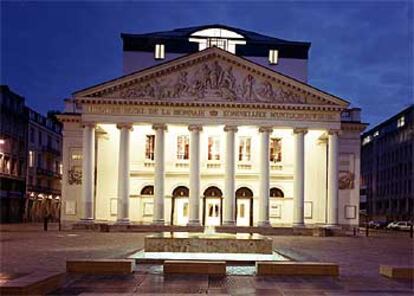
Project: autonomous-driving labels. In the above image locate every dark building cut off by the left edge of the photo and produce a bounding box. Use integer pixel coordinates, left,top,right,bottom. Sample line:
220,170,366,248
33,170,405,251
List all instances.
0,85,28,223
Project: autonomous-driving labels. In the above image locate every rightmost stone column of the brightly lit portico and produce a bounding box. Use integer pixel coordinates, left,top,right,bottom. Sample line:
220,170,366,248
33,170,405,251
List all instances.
327,130,339,225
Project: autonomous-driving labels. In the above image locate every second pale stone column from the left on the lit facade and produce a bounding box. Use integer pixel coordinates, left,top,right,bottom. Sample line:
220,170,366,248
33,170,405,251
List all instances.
116,124,132,224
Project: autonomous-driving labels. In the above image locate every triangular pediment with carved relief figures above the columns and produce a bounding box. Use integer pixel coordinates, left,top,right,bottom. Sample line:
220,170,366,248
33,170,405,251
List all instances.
74,48,348,107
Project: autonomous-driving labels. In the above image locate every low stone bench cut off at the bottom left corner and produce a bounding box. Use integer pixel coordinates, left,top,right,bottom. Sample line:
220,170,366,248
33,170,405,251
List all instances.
0,271,65,295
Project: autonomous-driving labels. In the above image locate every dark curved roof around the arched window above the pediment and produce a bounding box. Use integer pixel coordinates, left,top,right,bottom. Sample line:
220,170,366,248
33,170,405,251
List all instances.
121,24,311,59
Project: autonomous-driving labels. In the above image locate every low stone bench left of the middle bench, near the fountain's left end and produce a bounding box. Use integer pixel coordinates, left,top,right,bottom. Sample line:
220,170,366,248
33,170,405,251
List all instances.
66,259,135,274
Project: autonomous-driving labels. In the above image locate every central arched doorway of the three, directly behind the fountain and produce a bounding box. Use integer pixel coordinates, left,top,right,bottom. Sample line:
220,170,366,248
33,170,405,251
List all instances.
203,186,223,226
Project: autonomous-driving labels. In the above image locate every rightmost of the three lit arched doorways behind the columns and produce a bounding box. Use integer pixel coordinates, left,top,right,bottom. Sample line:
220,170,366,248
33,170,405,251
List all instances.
236,187,253,226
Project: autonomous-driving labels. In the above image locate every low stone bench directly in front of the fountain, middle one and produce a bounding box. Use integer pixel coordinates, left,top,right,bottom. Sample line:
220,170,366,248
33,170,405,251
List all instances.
164,260,226,276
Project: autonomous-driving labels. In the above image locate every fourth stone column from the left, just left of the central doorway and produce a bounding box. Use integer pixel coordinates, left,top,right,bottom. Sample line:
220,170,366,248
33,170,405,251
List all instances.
188,125,203,226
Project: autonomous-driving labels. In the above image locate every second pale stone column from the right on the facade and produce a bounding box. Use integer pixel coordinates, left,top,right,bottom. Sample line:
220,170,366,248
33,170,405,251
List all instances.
293,128,308,226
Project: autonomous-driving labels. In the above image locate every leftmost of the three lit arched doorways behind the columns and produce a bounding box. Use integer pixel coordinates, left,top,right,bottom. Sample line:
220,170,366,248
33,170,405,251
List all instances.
171,186,190,225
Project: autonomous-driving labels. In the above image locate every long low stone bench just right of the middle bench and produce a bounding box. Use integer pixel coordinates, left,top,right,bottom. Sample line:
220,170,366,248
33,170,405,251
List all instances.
256,261,339,276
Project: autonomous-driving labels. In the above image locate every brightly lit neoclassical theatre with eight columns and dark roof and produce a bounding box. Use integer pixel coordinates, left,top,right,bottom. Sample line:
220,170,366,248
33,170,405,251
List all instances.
60,25,364,227
